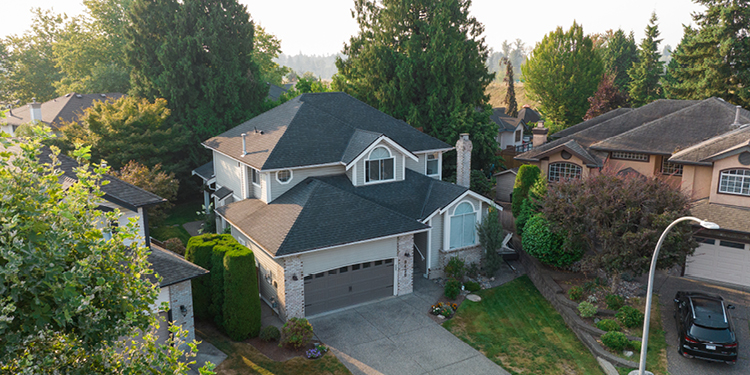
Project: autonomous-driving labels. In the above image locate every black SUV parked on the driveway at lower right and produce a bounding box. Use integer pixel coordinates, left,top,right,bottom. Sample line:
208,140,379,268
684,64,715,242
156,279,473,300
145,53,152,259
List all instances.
674,292,737,364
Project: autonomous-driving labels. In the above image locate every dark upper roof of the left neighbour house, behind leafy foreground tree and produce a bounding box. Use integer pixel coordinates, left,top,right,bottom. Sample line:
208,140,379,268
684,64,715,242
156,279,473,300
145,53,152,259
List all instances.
39,147,166,211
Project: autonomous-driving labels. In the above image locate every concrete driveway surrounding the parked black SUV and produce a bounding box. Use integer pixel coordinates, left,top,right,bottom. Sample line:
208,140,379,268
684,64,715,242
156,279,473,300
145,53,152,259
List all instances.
654,272,750,375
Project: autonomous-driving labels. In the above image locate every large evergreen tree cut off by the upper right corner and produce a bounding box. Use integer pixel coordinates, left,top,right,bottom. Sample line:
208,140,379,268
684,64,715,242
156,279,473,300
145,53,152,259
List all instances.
665,0,750,106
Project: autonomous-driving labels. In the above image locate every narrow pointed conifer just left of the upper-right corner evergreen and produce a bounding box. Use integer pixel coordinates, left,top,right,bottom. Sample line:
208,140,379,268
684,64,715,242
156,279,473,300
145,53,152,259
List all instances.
628,12,664,107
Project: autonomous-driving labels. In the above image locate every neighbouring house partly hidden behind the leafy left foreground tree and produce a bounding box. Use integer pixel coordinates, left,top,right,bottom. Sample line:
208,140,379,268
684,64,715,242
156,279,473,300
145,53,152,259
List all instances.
40,148,208,343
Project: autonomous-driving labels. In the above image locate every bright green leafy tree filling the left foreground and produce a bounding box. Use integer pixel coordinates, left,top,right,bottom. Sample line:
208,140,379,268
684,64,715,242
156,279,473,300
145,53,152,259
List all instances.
0,138,206,374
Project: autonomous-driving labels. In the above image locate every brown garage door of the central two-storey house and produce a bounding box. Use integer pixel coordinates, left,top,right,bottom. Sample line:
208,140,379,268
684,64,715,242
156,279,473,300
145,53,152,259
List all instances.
305,259,393,316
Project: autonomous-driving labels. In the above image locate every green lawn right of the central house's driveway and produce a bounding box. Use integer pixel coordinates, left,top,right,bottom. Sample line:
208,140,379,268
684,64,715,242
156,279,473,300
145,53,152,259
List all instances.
444,276,603,375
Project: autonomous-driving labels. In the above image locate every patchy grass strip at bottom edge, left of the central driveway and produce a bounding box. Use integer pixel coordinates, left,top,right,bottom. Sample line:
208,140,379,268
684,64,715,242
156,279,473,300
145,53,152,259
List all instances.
196,328,351,375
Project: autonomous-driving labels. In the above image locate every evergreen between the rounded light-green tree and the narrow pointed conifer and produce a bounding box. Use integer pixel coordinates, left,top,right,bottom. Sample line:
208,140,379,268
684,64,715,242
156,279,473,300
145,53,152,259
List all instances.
601,29,638,90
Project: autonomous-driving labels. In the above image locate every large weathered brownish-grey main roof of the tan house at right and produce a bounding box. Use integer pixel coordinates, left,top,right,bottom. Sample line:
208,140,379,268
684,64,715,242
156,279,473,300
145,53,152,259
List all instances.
591,98,750,155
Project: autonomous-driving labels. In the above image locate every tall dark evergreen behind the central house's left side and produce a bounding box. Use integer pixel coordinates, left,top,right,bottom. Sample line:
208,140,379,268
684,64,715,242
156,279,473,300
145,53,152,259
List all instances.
127,0,268,163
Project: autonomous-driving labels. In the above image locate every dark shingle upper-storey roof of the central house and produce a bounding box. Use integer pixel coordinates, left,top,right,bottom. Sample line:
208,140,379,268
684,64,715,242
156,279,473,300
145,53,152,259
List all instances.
203,92,451,170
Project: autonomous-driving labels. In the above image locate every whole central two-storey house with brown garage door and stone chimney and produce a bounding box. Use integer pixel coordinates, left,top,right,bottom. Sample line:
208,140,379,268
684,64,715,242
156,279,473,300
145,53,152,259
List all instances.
195,93,500,319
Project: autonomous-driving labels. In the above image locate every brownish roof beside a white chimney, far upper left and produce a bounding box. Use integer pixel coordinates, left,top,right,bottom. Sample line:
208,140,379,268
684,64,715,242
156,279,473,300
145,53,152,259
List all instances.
3,92,124,129
